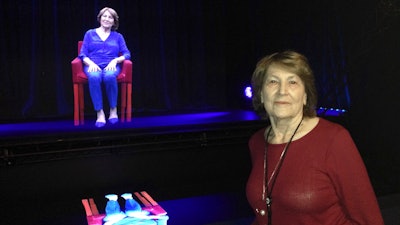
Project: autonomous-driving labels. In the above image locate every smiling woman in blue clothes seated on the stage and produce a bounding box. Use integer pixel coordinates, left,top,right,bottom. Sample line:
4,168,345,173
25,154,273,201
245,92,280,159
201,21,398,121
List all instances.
79,7,131,127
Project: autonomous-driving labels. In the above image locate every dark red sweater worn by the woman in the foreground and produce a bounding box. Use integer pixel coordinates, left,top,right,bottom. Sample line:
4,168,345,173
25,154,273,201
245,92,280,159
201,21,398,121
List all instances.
246,118,384,225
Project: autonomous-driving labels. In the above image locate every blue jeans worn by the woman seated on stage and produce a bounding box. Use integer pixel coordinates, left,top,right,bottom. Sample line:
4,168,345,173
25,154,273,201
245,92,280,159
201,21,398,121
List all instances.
84,65,121,112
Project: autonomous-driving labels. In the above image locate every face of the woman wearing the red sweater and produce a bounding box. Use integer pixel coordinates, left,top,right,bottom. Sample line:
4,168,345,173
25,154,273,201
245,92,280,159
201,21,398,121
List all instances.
261,65,307,119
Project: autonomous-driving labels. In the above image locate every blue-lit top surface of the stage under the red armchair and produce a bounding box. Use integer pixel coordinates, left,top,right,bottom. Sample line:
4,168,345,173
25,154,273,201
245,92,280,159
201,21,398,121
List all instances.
0,110,259,138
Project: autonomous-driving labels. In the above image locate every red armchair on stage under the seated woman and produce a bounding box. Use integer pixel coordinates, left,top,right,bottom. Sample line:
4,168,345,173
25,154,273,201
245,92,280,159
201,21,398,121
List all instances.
71,41,132,126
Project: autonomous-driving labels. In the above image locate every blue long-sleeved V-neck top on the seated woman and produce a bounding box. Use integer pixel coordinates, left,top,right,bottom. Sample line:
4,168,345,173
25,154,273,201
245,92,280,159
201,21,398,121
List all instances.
78,29,131,69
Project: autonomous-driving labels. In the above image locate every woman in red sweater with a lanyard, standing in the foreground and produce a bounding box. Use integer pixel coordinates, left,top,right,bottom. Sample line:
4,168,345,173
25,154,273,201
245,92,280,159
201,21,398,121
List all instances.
246,51,384,225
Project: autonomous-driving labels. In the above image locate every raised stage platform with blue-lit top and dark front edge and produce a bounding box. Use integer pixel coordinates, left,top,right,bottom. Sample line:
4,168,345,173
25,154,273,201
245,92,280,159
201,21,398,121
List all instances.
0,110,266,166
